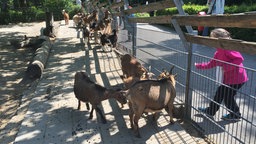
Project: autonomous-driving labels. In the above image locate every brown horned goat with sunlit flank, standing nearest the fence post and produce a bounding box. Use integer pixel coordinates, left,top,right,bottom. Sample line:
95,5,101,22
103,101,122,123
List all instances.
123,66,176,137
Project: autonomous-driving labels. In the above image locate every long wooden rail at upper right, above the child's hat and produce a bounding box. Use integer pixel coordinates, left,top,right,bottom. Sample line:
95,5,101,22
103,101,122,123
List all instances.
172,13,256,28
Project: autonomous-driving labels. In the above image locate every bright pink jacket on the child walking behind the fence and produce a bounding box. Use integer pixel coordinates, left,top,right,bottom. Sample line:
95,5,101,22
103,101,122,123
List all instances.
195,48,248,84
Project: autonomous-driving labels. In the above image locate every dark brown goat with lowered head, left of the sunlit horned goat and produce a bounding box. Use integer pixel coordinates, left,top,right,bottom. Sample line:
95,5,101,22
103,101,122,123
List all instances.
74,72,126,123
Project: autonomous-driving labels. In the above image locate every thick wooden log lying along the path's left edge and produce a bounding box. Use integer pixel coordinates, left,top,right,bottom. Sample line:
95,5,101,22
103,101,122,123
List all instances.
26,37,51,79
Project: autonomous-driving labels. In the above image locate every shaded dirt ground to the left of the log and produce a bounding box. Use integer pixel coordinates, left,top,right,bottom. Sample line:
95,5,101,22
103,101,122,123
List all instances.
0,22,45,142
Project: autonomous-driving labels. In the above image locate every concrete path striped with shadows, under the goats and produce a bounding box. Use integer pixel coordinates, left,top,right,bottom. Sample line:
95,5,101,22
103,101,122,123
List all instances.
15,22,202,144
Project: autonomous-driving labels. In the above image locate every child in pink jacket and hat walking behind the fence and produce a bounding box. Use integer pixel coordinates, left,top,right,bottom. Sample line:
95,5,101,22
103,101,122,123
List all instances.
195,28,248,120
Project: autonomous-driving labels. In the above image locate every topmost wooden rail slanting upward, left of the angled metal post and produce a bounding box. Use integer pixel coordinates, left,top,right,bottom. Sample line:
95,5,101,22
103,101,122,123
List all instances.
124,0,176,15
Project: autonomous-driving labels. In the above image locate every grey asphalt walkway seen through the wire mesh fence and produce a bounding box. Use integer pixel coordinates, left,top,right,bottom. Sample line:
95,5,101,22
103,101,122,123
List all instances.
116,14,256,144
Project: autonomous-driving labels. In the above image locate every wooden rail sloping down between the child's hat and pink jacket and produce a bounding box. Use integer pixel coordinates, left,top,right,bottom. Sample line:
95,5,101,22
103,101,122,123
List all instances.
185,34,256,55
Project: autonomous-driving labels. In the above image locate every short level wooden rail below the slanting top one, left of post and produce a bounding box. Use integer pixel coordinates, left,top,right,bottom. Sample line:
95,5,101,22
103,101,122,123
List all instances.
128,15,172,24
